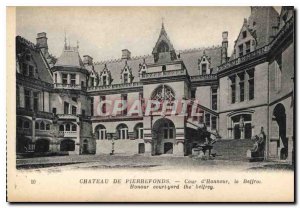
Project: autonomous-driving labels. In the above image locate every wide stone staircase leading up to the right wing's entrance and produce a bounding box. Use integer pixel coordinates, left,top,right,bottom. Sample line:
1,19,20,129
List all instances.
213,139,254,161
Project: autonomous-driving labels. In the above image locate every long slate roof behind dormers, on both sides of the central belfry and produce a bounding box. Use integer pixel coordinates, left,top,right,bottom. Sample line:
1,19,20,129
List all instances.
94,46,221,84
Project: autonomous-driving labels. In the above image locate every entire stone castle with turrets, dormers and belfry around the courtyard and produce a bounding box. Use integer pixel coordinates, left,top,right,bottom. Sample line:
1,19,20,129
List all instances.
16,7,295,160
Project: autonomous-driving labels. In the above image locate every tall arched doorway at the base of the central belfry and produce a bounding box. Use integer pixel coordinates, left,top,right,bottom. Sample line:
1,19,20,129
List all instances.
152,118,176,155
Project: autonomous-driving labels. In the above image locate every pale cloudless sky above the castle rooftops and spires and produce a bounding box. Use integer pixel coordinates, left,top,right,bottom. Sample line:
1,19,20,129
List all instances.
16,7,280,62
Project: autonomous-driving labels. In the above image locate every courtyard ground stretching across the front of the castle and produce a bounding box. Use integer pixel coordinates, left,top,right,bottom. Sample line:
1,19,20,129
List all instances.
17,155,292,171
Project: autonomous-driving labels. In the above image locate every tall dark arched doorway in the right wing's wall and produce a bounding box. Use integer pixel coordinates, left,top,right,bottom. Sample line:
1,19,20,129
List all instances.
273,103,288,160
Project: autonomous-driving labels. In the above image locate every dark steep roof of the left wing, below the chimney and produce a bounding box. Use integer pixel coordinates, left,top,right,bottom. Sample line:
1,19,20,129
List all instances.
16,36,53,83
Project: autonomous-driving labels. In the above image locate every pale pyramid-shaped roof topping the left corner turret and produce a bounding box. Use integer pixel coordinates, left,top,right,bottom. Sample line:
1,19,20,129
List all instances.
54,47,83,68
